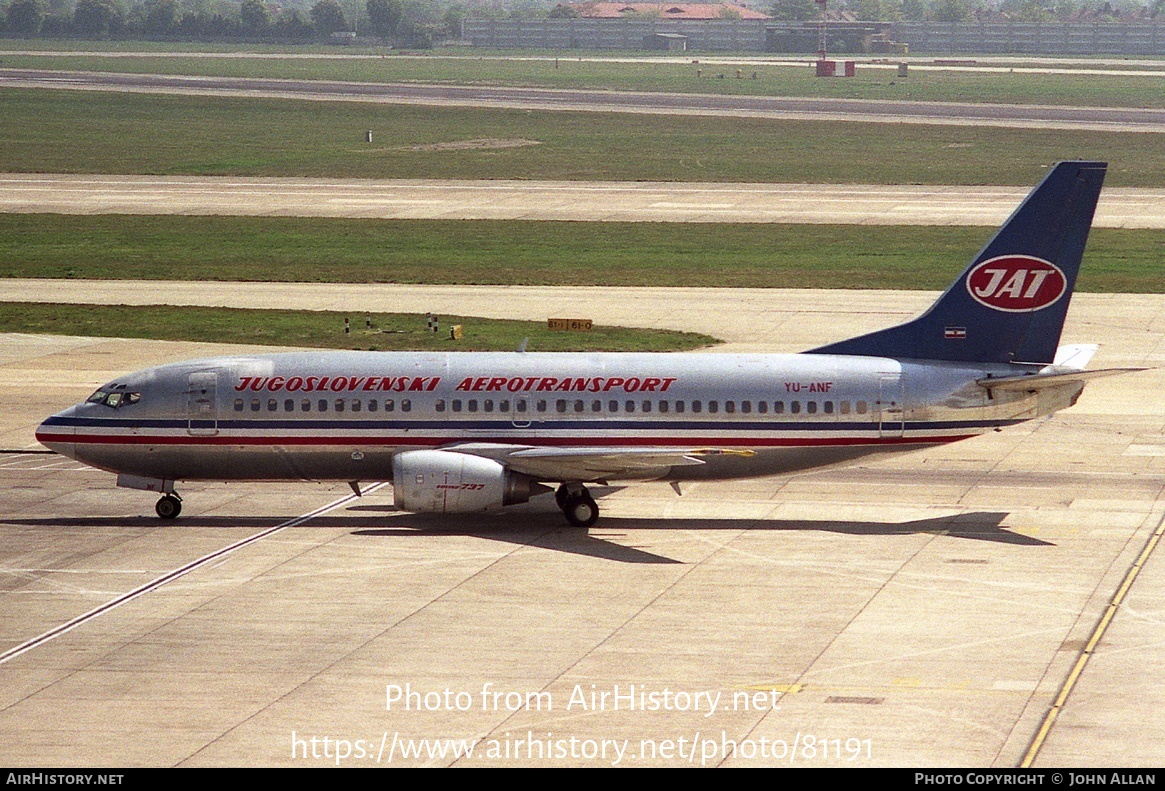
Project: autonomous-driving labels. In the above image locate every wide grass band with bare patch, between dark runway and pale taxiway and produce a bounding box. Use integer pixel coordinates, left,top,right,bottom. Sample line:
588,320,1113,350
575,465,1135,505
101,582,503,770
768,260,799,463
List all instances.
0,90,1165,186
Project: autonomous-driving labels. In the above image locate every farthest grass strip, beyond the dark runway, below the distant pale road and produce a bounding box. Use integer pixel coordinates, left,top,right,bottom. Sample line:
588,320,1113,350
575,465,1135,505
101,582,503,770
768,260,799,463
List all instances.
0,52,1165,107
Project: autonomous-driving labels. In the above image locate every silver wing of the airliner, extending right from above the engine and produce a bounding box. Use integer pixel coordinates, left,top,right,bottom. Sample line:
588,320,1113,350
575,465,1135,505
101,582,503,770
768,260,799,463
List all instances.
443,443,753,482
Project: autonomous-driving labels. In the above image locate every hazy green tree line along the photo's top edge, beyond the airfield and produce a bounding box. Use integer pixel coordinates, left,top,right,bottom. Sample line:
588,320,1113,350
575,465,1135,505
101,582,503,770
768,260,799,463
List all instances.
0,0,1165,41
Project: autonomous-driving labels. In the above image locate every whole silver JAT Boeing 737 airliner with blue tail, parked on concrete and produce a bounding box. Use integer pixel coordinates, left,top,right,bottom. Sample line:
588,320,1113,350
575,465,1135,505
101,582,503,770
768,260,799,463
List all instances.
36,162,1137,527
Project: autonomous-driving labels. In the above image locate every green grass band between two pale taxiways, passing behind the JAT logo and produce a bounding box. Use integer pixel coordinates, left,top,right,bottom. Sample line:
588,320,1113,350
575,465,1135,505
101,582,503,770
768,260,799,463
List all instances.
0,214,1165,292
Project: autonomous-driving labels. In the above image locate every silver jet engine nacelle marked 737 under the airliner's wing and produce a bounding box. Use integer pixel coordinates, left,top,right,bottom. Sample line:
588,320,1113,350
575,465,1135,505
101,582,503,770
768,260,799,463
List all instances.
393,451,550,514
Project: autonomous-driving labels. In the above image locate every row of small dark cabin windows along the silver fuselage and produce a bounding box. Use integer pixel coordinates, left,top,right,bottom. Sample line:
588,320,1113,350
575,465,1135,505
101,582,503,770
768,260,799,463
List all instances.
234,398,869,415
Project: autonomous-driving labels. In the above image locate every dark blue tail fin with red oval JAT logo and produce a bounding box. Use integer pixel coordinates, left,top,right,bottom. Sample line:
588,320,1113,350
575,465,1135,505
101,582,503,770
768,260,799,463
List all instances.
812,162,1107,363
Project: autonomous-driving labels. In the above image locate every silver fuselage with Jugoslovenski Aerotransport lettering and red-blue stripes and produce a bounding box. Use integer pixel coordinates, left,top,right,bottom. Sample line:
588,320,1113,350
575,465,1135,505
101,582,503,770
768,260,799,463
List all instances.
37,352,1080,481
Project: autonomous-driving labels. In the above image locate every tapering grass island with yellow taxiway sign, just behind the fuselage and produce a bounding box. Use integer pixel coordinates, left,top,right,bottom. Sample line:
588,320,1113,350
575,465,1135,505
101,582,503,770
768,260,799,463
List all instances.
0,302,719,352
